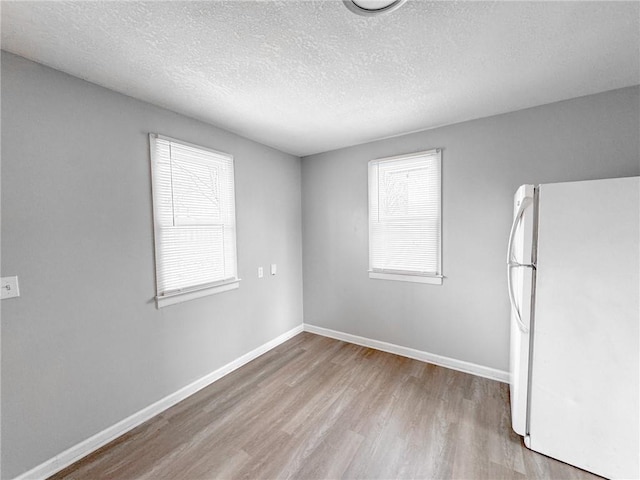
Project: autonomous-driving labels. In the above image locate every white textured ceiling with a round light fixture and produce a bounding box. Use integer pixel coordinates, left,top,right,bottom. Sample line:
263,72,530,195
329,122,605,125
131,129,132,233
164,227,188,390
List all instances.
1,1,640,156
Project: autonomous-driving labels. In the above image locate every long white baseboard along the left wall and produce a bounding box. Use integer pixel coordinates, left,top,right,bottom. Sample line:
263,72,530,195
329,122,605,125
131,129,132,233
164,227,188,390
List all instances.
14,325,303,480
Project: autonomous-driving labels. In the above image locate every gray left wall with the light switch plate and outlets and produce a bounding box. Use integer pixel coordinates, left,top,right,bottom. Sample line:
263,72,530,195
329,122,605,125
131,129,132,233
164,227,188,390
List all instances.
1,52,302,478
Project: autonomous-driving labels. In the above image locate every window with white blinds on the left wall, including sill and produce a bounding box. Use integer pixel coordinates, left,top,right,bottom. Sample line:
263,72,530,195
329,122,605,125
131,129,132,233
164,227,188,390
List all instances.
149,134,239,307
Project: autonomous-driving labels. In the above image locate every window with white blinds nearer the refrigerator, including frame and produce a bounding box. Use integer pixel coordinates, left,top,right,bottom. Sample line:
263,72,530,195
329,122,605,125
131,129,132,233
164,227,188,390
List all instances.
369,149,442,285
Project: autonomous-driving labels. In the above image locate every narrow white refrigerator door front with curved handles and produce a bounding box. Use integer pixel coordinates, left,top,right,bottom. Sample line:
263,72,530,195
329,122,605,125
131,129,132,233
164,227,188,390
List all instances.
507,185,534,436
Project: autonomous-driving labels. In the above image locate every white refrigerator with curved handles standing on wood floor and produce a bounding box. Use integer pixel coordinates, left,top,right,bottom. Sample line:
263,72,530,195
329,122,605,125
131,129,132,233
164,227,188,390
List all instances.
507,177,640,479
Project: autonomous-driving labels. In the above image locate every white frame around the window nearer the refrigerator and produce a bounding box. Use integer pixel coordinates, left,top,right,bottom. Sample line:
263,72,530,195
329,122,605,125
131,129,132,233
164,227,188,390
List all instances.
368,148,444,285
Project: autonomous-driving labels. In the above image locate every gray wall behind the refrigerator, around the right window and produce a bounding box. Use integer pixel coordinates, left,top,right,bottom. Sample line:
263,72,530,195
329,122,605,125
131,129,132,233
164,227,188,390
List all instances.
302,87,640,371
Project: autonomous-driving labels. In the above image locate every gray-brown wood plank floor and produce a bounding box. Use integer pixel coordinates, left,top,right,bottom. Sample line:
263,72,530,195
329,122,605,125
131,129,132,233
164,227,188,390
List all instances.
51,333,600,480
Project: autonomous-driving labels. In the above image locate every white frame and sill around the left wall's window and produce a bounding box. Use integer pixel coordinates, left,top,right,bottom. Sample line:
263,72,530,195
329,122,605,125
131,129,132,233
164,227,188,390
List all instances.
149,133,240,308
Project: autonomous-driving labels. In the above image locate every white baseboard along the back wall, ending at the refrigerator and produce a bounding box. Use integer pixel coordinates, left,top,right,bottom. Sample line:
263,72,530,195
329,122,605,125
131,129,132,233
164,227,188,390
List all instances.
304,323,509,383
